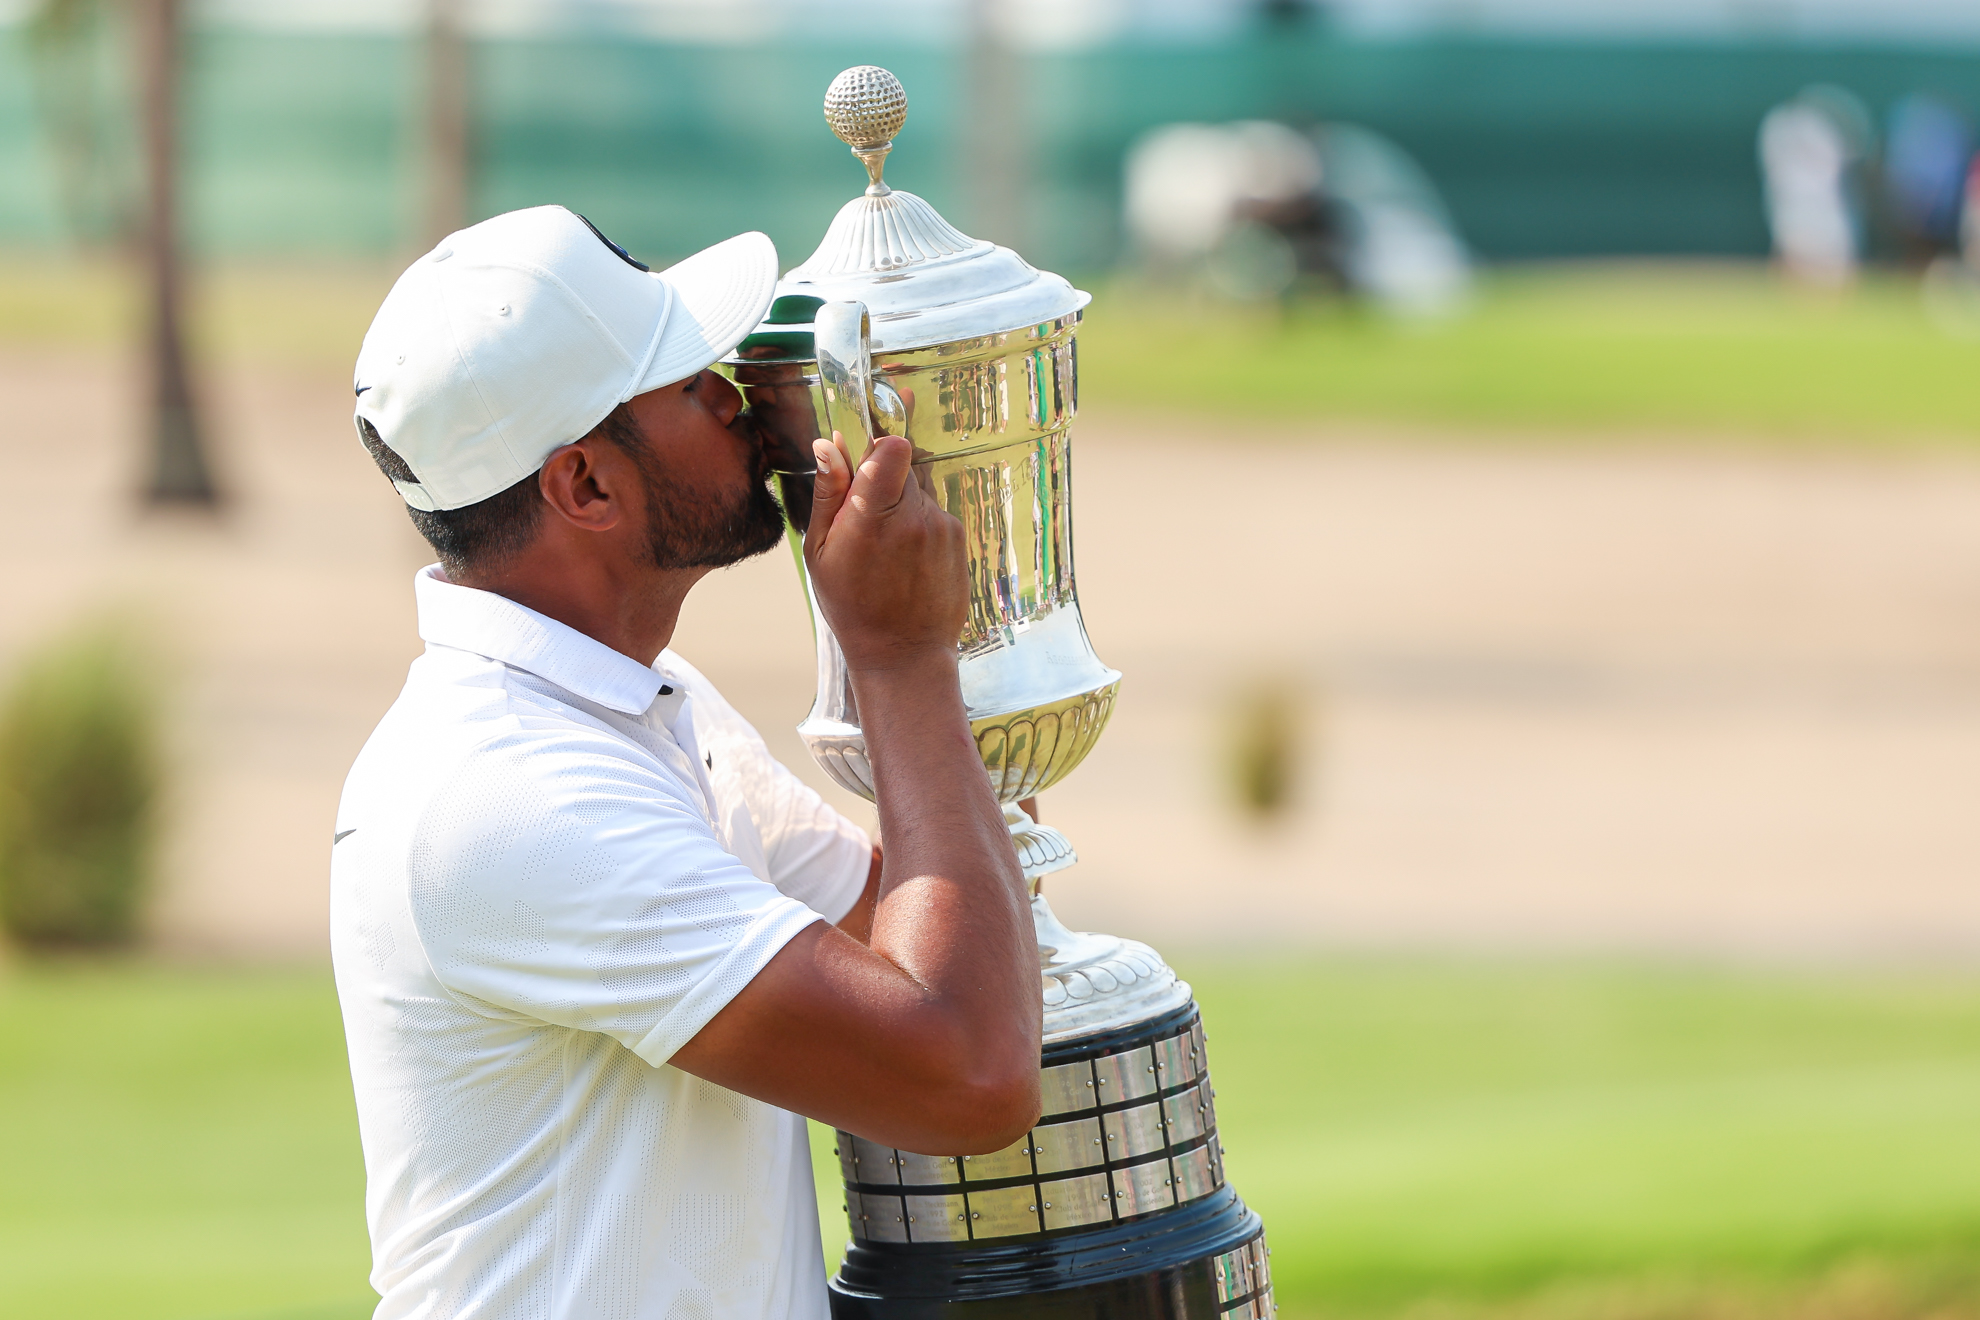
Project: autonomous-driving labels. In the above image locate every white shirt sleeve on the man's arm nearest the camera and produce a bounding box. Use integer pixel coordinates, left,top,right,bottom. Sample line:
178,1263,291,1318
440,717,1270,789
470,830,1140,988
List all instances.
408,730,820,1067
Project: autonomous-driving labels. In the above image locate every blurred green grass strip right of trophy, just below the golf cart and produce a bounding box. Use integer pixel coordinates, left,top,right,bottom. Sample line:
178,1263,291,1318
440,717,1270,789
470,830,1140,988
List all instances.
1079,263,1980,443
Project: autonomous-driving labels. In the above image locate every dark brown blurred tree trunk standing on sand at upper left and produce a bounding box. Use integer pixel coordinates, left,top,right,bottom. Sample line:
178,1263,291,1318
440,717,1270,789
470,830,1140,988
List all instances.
135,0,220,507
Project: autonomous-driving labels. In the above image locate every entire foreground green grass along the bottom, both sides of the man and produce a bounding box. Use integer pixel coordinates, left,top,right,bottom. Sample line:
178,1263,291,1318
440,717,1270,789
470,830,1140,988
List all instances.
0,958,1980,1320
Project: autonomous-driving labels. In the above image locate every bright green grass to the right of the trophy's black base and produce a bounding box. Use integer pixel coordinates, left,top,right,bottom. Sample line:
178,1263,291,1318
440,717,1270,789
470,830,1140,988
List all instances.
1182,964,1980,1306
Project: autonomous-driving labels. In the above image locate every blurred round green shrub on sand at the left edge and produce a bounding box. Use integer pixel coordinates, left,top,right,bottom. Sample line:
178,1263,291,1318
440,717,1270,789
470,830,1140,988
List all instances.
0,623,160,948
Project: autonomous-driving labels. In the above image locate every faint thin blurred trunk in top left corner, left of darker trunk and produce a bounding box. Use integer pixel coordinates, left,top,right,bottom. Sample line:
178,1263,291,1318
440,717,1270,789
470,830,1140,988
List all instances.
24,0,135,247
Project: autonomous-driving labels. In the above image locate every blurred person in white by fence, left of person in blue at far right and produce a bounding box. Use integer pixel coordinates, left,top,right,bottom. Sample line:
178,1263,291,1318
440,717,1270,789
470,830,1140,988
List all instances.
1760,87,1871,285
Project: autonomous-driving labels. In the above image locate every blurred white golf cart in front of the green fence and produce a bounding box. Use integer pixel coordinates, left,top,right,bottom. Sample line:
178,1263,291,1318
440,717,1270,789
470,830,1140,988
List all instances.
1125,121,1469,313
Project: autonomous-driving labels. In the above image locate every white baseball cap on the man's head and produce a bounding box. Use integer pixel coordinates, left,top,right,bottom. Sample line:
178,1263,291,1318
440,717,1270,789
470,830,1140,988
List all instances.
354,206,776,509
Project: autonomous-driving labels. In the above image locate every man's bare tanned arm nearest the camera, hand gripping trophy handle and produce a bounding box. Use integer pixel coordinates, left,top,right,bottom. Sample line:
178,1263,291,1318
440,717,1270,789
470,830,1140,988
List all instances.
671,437,1041,1156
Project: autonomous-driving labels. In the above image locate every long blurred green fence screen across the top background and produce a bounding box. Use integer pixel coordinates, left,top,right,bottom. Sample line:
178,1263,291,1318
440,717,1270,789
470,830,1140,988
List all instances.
0,30,1980,269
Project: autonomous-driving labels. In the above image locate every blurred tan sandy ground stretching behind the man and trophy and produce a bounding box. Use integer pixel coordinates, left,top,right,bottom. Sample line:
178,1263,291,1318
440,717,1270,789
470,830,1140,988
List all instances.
0,350,1980,956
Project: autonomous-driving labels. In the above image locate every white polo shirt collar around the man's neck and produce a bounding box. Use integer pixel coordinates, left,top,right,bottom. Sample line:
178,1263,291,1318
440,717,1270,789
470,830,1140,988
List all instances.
412,564,661,714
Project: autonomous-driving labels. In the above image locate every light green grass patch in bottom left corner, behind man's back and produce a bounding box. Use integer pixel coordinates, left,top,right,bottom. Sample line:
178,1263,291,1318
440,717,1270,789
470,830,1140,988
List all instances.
0,960,376,1320
